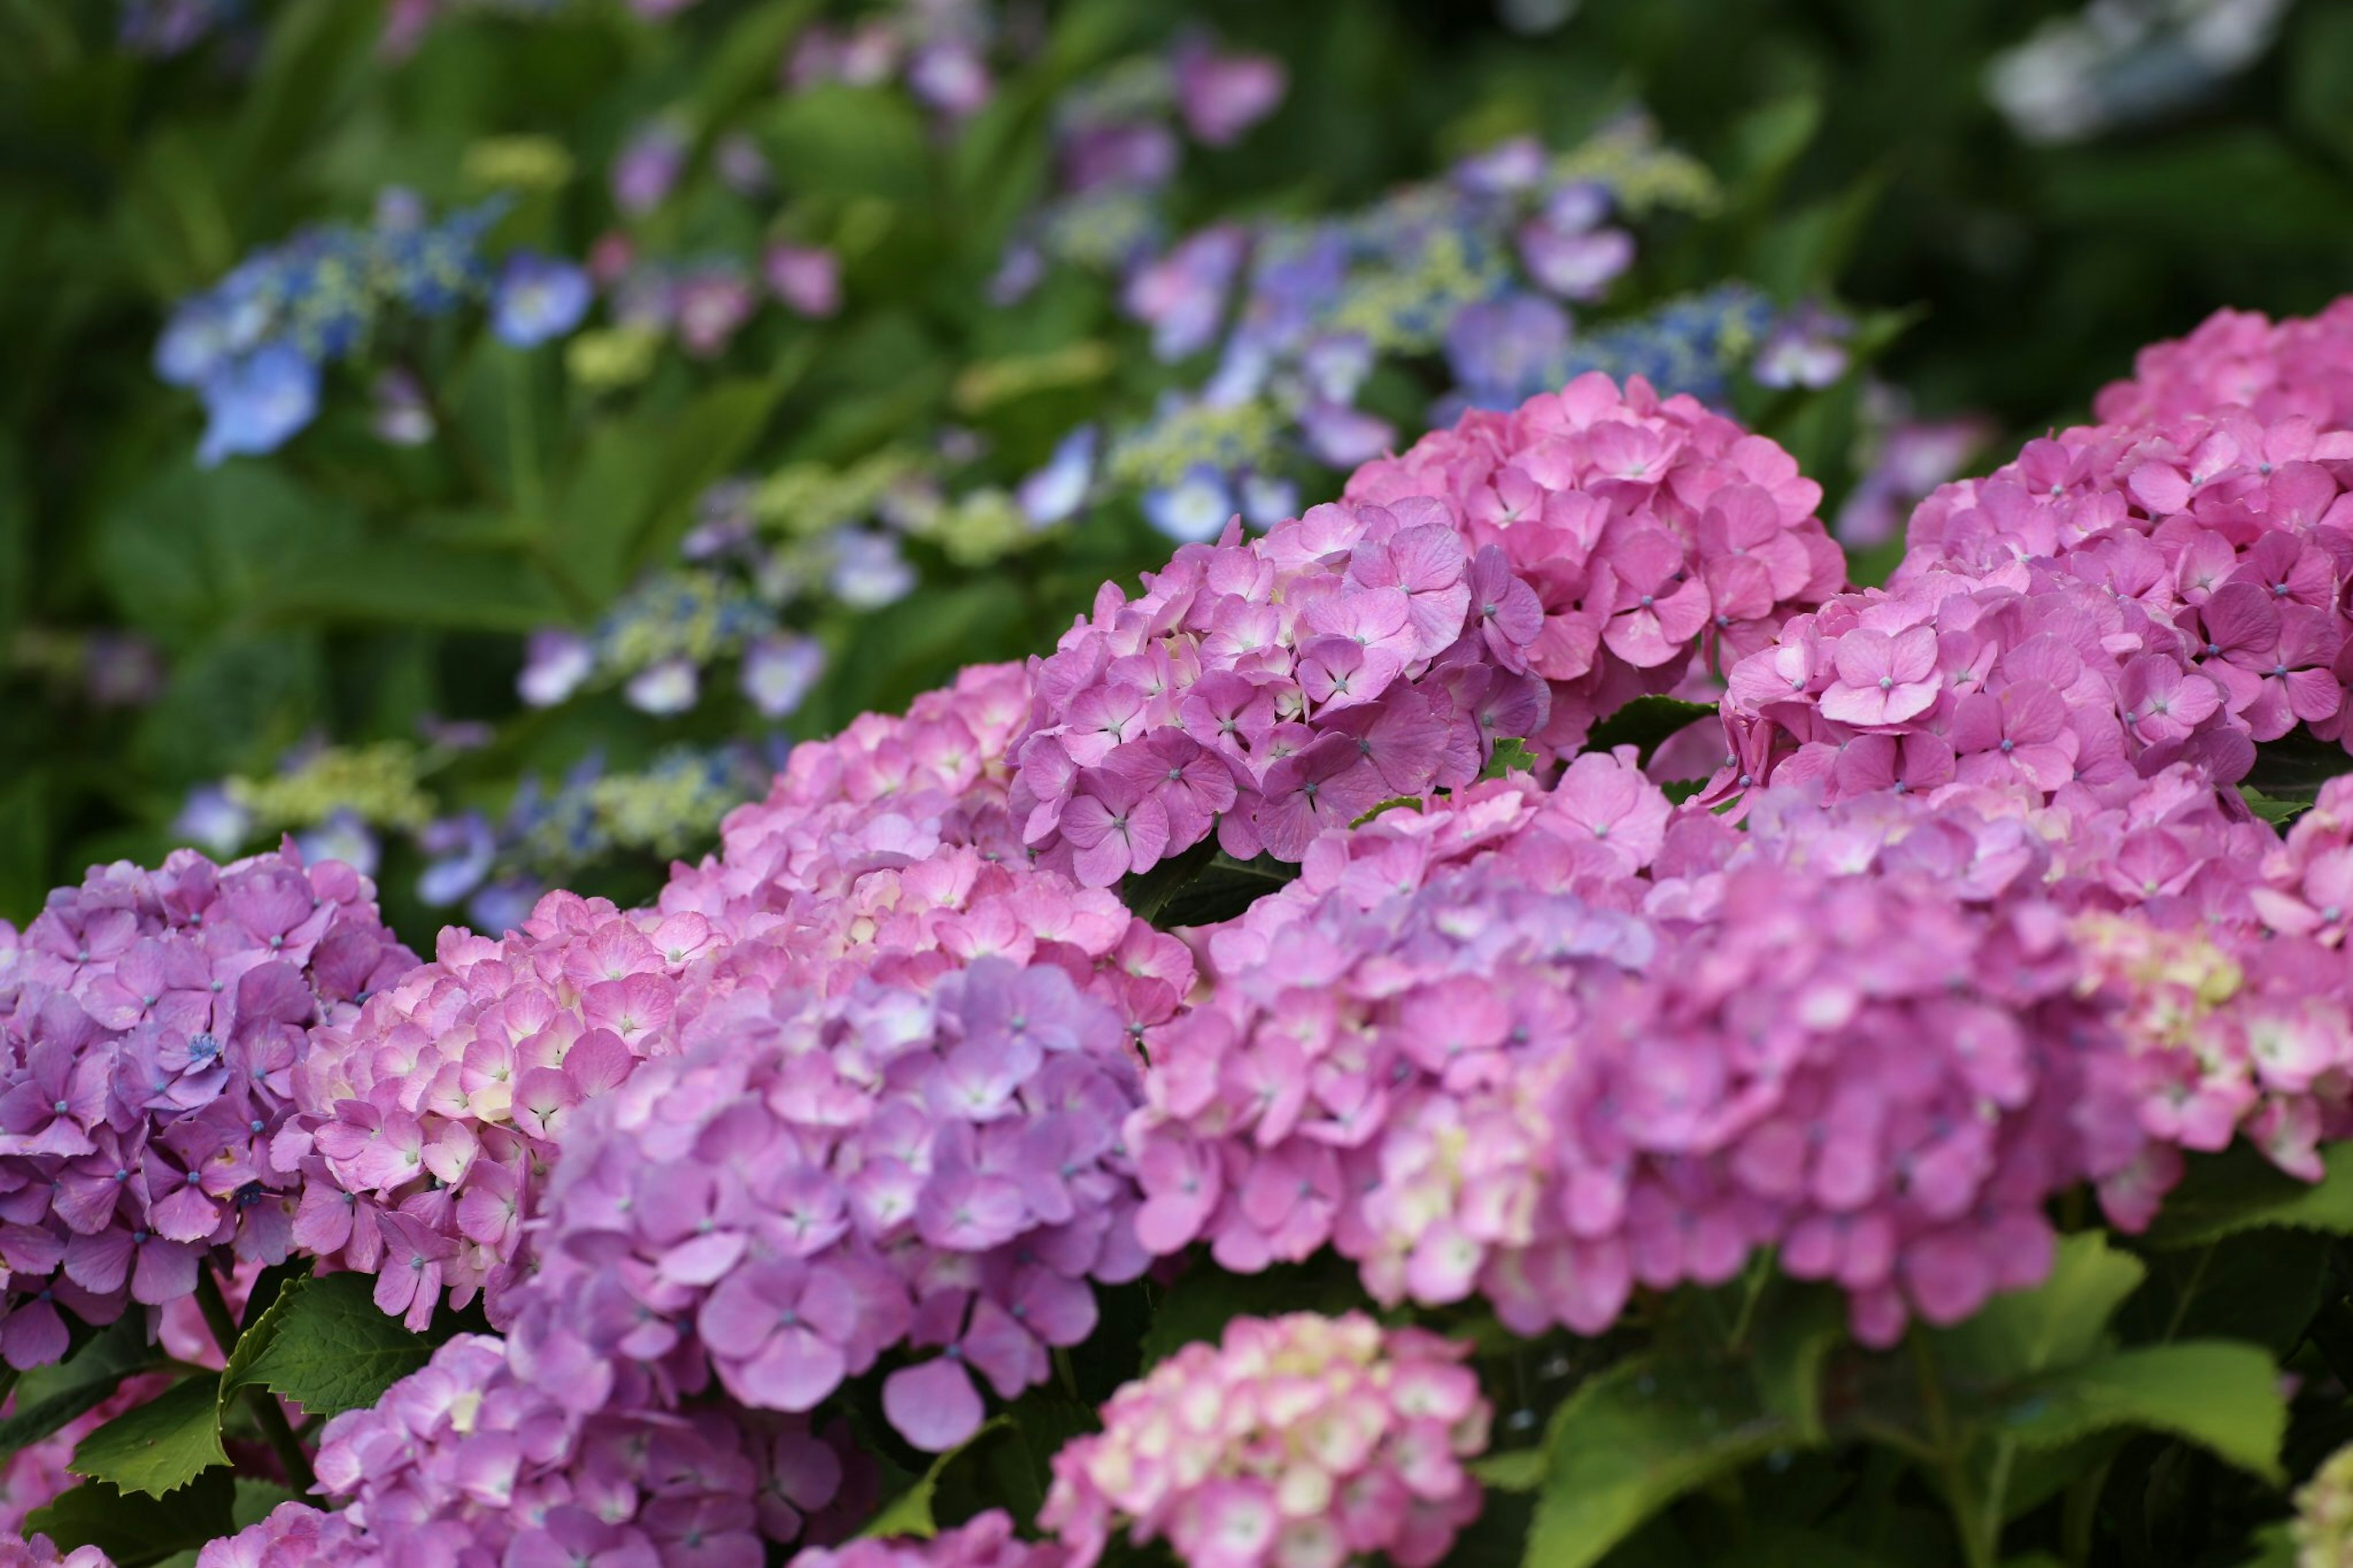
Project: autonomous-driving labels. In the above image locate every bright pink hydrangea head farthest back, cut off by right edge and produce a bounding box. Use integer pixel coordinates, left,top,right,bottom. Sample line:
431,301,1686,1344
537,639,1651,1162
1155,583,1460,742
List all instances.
2092,299,2353,431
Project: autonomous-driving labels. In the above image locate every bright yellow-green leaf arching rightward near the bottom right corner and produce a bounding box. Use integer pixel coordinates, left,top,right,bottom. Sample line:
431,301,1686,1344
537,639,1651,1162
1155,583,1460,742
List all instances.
1998,1339,2287,1486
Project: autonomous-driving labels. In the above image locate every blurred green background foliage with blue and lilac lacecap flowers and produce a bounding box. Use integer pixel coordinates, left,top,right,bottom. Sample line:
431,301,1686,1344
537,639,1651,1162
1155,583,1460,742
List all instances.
0,0,2353,942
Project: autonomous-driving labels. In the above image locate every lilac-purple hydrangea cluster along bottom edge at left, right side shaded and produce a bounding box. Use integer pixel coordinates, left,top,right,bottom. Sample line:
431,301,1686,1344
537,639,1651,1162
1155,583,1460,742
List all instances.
200,1335,871,1568
